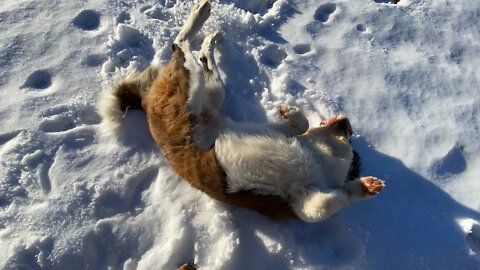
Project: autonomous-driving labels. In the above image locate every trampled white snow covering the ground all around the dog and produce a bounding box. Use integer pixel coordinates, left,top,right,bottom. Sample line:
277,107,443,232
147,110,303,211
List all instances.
0,0,480,270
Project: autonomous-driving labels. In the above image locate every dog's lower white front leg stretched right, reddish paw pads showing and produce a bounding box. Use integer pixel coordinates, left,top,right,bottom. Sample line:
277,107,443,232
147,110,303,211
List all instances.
290,177,385,222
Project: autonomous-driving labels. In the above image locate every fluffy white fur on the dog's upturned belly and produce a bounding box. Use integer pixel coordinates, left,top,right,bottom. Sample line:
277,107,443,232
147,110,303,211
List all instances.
215,126,319,198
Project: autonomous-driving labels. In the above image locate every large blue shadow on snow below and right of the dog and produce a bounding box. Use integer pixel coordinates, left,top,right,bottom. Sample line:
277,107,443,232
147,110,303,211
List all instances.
222,139,480,269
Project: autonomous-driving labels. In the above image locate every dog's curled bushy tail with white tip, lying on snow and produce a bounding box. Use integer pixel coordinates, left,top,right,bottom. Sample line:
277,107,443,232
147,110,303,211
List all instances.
97,66,159,134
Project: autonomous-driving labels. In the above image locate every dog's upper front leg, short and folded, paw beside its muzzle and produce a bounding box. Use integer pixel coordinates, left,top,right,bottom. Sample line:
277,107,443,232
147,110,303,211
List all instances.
269,104,308,136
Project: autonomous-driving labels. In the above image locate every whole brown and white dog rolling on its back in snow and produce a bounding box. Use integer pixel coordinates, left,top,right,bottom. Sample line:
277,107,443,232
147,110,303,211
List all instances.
99,0,384,222
